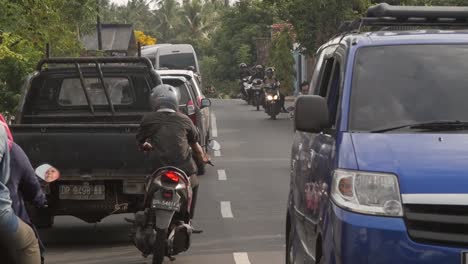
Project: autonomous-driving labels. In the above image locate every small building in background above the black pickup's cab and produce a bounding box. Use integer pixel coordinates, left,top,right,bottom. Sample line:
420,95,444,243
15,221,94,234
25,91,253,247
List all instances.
81,24,138,56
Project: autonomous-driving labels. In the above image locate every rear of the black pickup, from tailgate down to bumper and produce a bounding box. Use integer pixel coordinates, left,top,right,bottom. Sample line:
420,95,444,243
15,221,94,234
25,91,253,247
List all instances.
11,124,151,223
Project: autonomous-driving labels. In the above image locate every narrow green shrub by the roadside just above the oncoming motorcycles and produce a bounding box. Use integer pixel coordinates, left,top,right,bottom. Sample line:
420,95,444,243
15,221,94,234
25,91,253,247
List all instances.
269,29,296,95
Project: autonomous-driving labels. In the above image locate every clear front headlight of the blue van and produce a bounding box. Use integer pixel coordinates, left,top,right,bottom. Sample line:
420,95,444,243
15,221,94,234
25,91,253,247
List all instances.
331,170,403,217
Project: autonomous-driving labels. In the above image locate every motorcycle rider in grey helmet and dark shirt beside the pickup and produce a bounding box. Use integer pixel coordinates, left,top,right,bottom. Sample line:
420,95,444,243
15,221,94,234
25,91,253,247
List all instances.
136,84,210,219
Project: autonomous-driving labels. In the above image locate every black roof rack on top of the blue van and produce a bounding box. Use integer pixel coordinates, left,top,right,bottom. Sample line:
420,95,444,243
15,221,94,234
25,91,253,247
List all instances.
339,3,468,34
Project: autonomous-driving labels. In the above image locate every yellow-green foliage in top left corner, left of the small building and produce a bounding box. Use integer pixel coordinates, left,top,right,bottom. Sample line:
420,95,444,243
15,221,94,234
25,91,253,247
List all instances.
0,0,95,113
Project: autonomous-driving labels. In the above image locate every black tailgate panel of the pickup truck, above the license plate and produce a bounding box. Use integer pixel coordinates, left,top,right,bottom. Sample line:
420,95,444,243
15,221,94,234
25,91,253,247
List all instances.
11,124,149,178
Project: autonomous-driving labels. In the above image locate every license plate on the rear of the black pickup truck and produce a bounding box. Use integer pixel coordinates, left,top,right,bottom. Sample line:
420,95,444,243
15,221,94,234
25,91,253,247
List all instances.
59,183,106,200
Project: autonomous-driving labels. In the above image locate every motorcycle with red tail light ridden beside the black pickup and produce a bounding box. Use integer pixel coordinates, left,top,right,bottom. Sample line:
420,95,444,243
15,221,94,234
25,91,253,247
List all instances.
125,141,220,264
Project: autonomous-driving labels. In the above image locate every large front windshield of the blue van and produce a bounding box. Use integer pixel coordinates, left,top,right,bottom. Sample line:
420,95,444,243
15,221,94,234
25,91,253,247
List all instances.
349,45,468,131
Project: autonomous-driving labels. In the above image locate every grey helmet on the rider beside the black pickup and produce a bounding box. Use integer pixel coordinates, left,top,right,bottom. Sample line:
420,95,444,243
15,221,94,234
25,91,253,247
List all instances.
150,84,180,111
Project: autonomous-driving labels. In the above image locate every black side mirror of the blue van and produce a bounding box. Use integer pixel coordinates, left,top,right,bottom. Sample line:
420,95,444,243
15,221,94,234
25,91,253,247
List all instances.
294,95,330,133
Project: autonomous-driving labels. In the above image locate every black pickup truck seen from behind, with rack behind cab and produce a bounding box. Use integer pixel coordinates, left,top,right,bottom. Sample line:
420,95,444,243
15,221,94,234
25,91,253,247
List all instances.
12,57,161,227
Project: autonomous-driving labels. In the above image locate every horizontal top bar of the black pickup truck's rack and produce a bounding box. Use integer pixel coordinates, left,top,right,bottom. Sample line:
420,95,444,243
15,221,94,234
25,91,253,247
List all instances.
36,57,153,71
